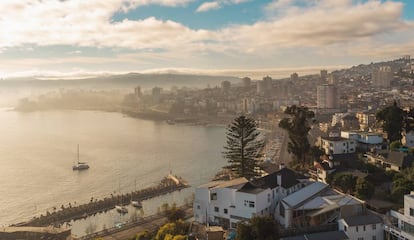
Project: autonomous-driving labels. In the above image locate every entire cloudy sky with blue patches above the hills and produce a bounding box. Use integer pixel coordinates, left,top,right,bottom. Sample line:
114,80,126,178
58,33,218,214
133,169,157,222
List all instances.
0,0,414,77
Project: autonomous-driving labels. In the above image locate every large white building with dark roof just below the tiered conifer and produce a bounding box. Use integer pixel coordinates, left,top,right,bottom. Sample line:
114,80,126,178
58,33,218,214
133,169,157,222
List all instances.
193,168,308,228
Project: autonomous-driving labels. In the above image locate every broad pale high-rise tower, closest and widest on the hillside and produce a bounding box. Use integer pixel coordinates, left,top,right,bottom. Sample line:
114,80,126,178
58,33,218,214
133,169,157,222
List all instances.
316,84,339,109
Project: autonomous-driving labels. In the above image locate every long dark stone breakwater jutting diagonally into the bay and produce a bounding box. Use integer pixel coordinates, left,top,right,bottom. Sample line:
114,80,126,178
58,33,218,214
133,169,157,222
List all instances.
16,175,189,227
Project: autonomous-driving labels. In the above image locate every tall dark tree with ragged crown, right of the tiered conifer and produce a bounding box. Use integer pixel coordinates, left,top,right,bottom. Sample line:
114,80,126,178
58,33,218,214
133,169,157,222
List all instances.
279,105,315,164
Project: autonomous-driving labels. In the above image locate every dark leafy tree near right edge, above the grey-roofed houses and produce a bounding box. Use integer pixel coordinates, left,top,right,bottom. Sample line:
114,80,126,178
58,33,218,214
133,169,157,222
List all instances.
375,101,406,142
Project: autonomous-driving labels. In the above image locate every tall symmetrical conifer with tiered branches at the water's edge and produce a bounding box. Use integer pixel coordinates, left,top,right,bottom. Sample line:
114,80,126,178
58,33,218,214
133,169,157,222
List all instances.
223,116,264,179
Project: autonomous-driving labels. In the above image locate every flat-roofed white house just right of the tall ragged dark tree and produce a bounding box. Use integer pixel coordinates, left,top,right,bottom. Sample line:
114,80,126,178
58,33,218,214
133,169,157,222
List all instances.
320,137,356,155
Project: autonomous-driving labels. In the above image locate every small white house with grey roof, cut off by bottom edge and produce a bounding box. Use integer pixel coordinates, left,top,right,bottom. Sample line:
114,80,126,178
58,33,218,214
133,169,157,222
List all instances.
338,214,384,240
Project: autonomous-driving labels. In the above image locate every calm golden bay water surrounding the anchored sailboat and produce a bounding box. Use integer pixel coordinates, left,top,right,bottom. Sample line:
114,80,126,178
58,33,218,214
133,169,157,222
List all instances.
0,109,225,227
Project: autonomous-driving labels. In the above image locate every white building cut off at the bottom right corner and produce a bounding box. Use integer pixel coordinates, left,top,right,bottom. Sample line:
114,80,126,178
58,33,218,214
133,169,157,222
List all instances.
384,191,414,240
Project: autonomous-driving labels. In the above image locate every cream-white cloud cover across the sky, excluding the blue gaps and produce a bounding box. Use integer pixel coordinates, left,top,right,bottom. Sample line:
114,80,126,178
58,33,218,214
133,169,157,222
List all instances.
0,0,414,75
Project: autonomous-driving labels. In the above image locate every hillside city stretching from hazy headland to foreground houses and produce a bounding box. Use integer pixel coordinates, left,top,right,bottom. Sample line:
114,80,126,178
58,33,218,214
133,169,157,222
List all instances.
4,55,414,240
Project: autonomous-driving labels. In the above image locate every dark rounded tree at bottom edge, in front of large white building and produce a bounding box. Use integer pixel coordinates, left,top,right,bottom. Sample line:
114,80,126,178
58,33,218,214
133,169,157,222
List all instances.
236,216,279,240
